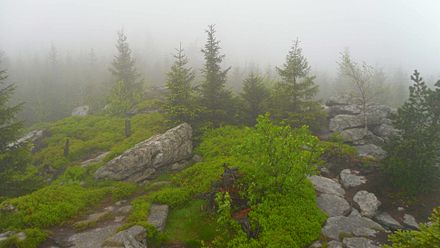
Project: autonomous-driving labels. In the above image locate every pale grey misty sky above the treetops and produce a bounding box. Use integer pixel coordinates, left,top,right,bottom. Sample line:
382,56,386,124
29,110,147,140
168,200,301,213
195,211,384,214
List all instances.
0,0,440,76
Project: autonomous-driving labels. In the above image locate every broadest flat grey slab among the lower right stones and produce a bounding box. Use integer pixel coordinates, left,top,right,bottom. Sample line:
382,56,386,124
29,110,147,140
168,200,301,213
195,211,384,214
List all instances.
321,216,385,240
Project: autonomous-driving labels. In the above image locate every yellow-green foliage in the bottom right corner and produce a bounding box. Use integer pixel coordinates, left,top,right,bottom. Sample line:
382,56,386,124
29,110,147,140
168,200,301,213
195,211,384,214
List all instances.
385,207,440,248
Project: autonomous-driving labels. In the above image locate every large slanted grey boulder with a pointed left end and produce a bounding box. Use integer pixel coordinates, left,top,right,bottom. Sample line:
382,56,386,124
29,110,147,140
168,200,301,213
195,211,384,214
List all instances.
95,123,192,182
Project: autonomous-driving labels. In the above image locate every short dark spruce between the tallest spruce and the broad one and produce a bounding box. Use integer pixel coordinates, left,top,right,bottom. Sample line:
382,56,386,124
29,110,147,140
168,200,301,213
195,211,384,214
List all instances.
240,73,269,126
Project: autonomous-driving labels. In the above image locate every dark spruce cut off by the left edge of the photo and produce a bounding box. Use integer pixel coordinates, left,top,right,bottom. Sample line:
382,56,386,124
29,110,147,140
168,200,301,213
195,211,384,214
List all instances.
0,54,22,152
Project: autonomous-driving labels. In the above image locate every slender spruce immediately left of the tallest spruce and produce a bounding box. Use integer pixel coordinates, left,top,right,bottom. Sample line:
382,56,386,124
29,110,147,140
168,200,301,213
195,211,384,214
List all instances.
163,43,198,124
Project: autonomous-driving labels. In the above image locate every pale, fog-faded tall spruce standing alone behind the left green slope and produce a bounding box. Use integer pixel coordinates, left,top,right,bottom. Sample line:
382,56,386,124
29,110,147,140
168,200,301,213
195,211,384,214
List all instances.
107,30,142,115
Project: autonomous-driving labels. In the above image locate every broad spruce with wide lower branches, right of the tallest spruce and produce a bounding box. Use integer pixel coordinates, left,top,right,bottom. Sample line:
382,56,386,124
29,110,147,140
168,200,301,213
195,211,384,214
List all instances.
271,39,325,129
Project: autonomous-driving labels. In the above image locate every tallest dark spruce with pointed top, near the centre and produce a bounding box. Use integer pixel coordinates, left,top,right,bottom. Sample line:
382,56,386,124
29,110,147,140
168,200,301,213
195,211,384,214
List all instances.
200,25,233,127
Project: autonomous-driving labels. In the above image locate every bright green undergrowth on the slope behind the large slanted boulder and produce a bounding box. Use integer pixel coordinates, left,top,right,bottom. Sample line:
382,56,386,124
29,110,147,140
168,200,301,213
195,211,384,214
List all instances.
33,113,163,169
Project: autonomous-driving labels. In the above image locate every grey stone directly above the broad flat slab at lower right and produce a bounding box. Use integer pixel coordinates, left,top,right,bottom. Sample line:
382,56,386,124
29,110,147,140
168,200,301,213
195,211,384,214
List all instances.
317,194,351,217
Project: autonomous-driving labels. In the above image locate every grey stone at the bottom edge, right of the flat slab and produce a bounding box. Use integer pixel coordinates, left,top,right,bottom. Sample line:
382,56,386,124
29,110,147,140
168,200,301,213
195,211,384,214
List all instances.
105,225,147,248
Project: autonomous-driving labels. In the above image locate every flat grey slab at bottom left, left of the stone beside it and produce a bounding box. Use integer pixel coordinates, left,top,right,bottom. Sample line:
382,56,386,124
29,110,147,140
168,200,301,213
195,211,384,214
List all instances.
68,224,120,248
